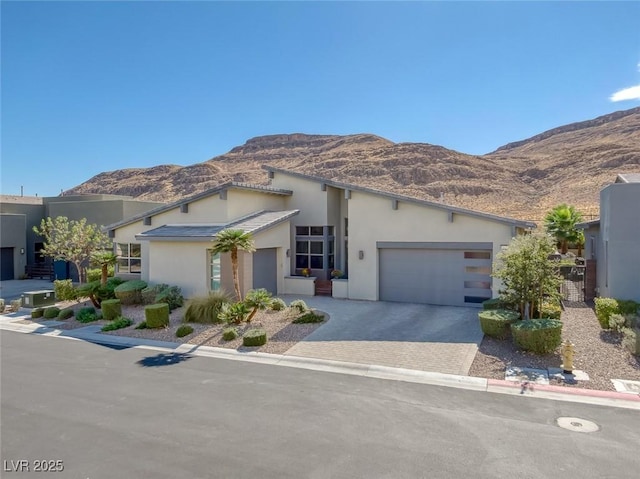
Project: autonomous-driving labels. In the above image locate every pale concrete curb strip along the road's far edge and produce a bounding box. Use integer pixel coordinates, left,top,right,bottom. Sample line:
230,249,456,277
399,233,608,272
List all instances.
0,323,640,410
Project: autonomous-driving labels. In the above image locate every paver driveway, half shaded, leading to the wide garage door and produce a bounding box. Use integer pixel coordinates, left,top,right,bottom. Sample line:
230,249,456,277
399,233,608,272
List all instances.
285,296,482,376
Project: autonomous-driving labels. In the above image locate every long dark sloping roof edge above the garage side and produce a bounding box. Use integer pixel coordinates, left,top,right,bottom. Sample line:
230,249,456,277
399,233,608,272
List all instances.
262,166,536,228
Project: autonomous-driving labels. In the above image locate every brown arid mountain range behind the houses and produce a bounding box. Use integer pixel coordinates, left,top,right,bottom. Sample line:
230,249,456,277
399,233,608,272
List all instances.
64,107,640,221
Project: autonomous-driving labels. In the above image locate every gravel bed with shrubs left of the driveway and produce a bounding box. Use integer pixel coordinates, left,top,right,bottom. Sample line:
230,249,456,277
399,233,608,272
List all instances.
43,302,329,354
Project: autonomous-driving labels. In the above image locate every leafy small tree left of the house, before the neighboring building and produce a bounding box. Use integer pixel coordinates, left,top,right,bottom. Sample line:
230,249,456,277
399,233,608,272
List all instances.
33,216,111,283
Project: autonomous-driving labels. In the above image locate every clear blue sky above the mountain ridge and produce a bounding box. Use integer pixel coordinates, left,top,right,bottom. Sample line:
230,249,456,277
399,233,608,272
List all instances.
1,1,640,196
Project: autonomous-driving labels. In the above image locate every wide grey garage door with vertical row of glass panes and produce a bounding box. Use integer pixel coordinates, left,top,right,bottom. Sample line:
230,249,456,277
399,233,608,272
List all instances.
378,242,493,307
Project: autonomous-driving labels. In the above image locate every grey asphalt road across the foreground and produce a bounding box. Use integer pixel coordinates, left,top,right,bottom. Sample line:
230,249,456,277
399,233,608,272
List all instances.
0,331,640,479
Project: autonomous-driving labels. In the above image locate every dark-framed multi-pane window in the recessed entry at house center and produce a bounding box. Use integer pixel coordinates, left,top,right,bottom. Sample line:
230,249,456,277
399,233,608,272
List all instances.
295,226,335,274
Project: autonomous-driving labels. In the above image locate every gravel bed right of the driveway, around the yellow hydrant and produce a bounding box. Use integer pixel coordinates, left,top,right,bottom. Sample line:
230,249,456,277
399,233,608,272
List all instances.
469,303,640,391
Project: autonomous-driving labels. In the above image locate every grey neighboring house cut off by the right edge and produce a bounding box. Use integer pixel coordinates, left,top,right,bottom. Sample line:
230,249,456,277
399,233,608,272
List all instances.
577,173,640,301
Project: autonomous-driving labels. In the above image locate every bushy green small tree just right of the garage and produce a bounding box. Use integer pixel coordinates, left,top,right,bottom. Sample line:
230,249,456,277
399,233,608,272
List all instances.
493,234,561,319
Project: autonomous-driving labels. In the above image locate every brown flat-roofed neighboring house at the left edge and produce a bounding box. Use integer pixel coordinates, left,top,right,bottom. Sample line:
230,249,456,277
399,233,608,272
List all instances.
0,195,163,281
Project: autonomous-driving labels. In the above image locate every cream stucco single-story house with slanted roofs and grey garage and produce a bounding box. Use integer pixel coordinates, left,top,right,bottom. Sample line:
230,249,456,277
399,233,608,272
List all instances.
107,168,535,306
